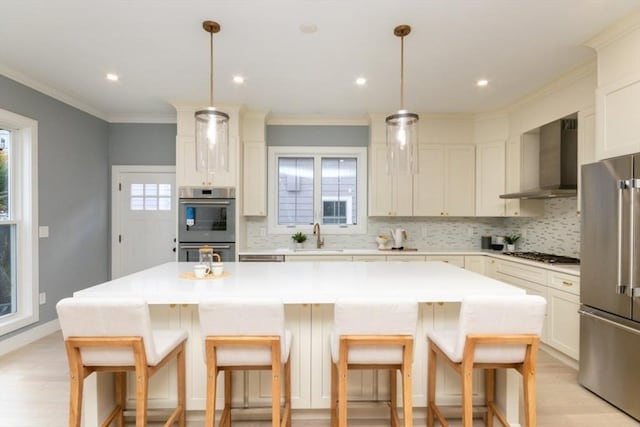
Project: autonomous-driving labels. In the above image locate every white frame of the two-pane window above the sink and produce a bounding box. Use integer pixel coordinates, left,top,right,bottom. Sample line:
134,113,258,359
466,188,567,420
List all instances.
267,146,367,234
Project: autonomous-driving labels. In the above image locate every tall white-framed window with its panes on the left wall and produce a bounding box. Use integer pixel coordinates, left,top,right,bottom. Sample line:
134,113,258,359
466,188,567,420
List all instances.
0,109,38,335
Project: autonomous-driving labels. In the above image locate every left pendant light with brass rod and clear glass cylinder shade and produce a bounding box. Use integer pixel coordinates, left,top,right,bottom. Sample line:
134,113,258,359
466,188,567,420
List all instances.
196,21,229,175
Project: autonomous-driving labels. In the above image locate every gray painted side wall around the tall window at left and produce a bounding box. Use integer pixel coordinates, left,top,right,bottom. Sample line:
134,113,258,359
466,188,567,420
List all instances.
0,76,110,340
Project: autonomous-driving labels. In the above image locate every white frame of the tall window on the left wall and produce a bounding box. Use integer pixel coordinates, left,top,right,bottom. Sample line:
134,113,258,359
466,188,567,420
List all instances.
0,108,40,336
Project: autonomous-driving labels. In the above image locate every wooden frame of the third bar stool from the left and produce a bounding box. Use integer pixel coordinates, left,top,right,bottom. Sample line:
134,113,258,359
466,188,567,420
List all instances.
331,335,413,427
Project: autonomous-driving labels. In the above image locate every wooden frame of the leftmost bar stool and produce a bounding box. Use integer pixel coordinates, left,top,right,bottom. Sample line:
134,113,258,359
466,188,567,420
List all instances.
65,337,186,427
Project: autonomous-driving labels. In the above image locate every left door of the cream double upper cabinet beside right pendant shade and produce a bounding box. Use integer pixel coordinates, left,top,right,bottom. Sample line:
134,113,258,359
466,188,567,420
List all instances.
413,144,446,216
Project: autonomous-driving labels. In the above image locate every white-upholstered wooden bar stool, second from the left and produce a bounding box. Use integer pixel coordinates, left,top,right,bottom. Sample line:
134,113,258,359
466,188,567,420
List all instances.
199,299,291,427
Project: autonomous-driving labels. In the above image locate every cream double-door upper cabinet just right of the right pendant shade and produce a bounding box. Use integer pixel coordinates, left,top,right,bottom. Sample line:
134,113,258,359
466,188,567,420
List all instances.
413,144,475,216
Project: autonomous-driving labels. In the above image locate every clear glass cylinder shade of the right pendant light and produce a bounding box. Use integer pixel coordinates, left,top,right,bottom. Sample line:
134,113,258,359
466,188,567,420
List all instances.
385,110,418,175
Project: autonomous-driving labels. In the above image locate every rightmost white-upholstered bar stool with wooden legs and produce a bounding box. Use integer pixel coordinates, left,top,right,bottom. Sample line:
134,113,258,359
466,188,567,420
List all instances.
427,295,546,427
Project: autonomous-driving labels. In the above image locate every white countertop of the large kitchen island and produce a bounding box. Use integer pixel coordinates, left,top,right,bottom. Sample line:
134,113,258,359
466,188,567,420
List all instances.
74,262,524,304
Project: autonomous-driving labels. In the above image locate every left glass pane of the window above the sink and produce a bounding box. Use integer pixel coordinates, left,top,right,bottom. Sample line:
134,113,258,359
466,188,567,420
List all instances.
278,157,313,225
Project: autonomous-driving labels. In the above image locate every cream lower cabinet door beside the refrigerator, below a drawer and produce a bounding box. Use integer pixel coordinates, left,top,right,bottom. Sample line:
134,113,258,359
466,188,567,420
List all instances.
546,288,580,360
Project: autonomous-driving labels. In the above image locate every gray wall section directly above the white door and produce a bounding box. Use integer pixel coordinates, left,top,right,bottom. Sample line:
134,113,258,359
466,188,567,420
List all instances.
109,123,177,166
